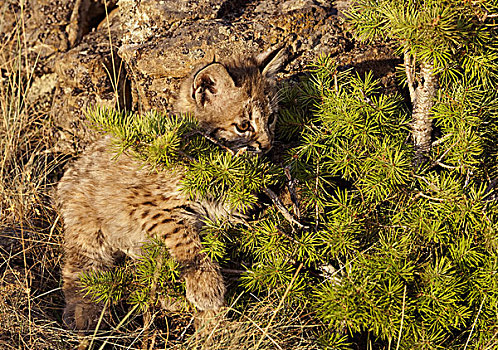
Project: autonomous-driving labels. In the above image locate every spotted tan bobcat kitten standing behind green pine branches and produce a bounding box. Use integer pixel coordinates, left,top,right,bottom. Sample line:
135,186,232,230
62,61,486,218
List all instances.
57,50,285,330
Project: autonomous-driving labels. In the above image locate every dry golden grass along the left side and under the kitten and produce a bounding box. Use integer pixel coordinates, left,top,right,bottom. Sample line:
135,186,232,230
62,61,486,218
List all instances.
0,6,322,350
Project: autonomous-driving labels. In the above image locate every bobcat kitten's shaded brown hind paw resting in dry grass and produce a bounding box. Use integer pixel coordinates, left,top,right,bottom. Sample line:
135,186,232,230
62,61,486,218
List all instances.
62,301,107,332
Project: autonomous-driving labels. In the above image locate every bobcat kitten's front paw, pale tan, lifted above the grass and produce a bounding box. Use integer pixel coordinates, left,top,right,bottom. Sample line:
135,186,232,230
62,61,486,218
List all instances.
185,263,226,310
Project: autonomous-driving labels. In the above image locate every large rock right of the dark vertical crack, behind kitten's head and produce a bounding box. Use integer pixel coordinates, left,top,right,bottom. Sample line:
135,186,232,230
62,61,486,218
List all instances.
118,0,337,111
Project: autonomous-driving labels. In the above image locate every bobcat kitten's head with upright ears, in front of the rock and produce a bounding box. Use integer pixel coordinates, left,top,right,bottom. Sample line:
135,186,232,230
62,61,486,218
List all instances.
176,49,285,153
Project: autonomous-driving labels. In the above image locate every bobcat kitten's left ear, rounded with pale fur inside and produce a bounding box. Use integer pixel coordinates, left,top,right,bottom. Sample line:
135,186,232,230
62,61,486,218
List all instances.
192,63,235,107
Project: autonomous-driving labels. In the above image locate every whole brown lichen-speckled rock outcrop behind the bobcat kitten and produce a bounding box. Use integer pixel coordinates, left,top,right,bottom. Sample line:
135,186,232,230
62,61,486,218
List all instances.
13,0,395,153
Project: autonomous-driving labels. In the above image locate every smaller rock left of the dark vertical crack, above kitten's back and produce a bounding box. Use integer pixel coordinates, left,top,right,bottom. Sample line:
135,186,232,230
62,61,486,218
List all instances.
51,17,124,153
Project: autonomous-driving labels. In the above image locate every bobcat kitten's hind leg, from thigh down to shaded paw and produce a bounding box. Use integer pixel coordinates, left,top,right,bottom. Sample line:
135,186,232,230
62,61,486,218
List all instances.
62,230,113,331
